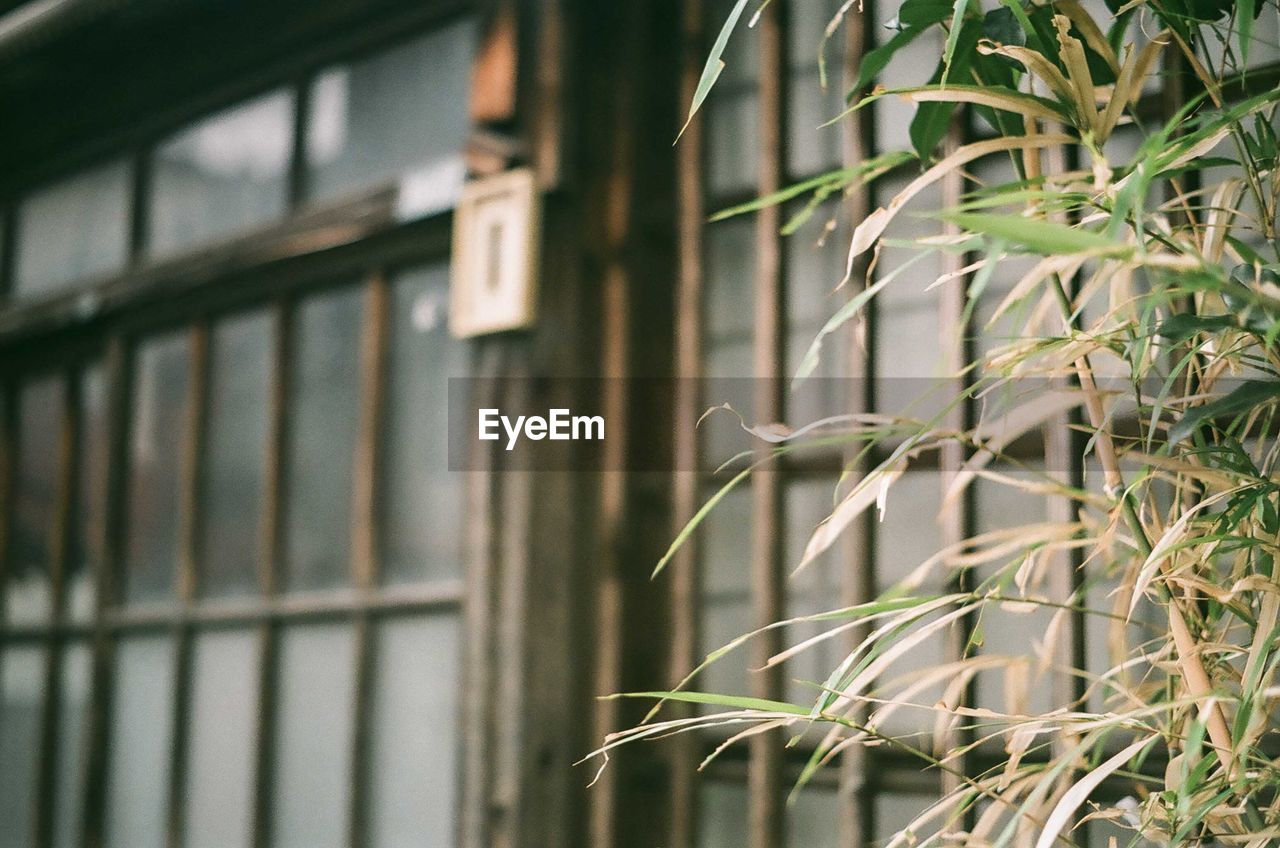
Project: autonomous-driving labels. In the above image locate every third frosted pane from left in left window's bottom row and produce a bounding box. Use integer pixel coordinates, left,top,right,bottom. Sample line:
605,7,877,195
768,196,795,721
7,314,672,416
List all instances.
106,637,174,848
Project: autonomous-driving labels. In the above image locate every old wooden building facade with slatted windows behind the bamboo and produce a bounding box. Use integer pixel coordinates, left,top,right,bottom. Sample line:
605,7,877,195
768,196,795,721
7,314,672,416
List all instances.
0,0,1275,848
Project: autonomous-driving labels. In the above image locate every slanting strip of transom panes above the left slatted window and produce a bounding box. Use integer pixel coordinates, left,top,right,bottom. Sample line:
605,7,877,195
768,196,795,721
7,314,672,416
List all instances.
3,17,477,301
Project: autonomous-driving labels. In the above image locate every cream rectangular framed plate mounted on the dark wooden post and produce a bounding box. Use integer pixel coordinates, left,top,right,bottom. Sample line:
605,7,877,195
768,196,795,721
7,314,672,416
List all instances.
449,168,539,338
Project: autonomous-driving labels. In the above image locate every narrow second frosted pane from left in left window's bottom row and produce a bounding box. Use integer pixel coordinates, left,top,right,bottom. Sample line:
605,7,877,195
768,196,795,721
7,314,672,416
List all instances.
54,642,93,848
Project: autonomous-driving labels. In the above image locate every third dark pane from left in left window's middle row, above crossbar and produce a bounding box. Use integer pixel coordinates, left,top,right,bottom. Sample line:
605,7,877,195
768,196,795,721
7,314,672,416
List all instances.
124,333,189,601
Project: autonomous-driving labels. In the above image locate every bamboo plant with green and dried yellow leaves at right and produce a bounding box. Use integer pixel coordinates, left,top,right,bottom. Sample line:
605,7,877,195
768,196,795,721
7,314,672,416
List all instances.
588,0,1280,848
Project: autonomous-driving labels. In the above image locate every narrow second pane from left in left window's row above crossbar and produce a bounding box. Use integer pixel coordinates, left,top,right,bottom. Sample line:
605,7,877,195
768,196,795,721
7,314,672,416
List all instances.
67,364,106,621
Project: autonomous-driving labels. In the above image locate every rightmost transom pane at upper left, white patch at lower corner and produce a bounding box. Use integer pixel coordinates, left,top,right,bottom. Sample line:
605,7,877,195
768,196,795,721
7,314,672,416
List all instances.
307,20,476,213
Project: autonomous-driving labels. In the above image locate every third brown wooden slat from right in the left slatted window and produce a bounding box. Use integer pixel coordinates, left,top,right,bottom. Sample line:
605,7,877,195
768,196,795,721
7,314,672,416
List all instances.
168,320,209,848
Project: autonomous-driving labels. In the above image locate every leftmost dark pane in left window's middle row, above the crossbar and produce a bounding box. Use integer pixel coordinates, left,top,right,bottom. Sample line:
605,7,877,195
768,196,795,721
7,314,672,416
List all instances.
6,377,65,624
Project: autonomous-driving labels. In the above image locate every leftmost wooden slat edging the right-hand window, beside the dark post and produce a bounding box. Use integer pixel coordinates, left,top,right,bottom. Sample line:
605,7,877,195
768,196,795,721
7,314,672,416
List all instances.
668,0,707,848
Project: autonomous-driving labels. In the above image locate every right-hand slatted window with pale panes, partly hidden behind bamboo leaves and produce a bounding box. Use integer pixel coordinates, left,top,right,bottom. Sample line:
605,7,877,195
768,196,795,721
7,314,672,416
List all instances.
672,1,1074,848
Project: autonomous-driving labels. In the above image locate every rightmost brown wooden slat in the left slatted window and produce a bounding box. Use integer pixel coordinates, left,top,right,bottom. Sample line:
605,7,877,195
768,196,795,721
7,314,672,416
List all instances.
348,273,388,848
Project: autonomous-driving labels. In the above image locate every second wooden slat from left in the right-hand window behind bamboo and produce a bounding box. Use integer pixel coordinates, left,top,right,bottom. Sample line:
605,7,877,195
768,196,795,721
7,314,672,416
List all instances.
748,3,787,848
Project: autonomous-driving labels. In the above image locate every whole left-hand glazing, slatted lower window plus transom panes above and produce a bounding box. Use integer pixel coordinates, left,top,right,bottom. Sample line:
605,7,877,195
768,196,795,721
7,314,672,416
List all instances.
0,14,475,848
